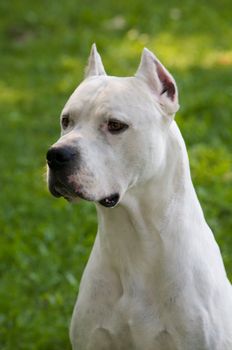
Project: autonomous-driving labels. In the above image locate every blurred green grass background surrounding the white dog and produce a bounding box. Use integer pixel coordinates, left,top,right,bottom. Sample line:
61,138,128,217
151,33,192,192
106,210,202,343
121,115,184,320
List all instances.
0,0,232,350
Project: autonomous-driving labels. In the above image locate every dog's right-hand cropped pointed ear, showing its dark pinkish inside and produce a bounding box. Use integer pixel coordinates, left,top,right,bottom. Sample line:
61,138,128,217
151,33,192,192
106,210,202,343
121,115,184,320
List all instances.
135,48,179,116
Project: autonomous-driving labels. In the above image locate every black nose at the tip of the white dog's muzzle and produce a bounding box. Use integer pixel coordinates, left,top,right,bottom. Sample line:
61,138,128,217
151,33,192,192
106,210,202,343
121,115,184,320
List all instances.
47,147,76,170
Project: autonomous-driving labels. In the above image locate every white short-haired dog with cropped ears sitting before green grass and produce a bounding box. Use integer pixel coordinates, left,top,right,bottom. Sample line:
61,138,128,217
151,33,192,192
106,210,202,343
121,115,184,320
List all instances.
47,45,232,350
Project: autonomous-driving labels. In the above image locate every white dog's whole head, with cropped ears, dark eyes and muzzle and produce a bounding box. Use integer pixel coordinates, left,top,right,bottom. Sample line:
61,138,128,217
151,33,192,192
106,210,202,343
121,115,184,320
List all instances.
47,45,178,207
